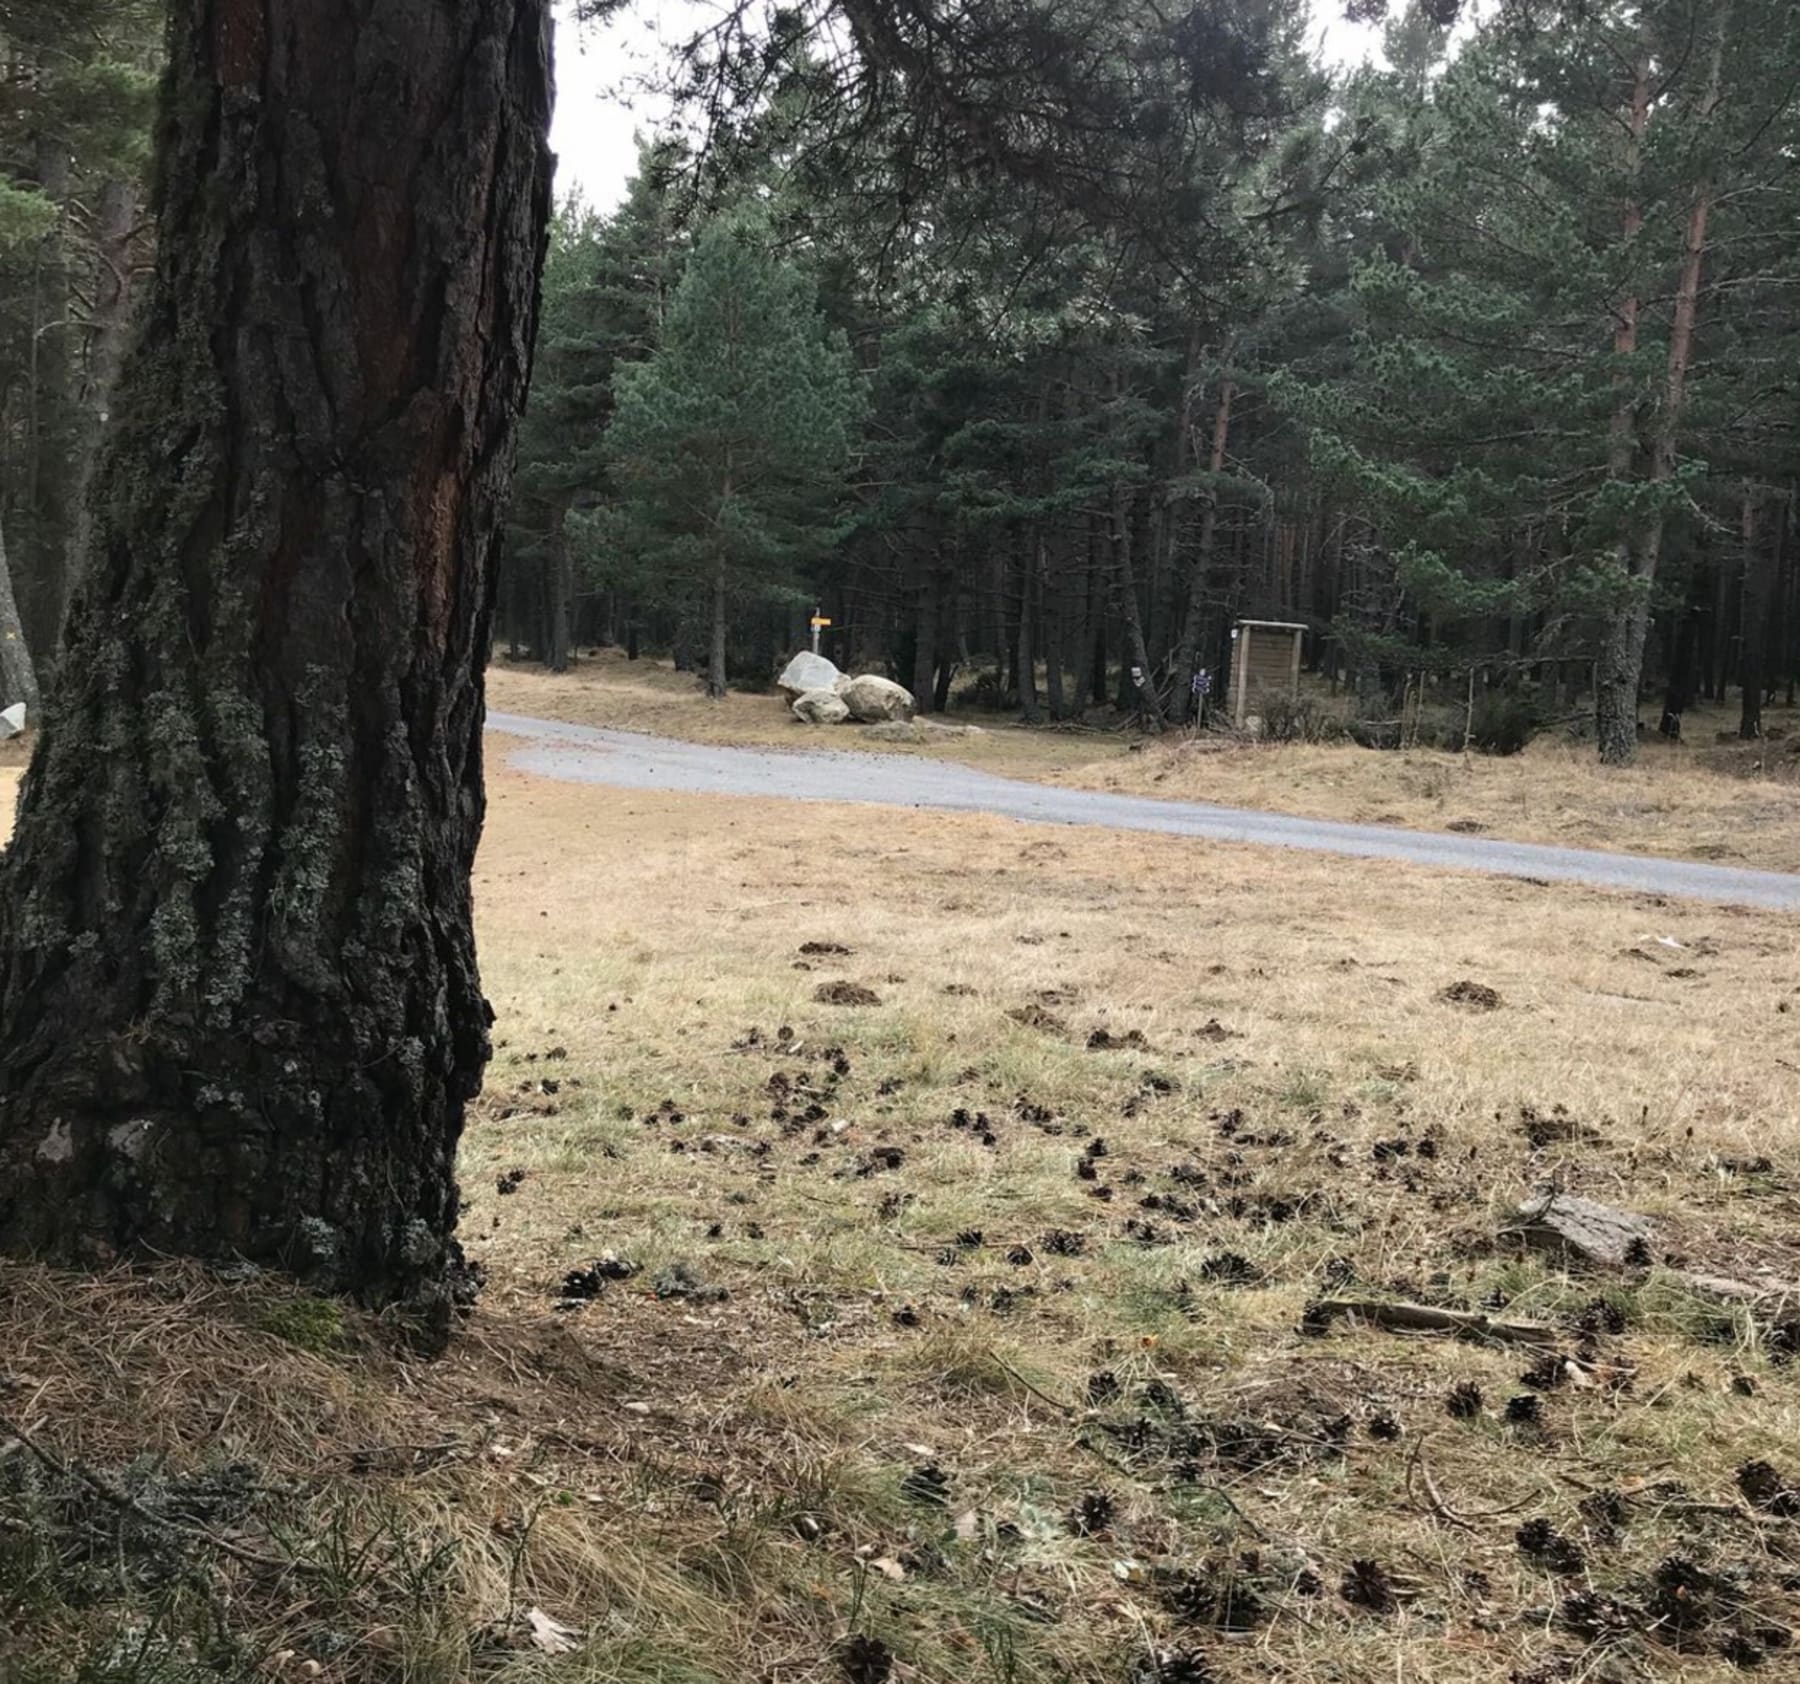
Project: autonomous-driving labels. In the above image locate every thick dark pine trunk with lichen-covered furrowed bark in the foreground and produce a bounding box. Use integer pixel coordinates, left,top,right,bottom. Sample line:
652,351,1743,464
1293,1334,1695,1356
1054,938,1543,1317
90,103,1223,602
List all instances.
0,0,549,1335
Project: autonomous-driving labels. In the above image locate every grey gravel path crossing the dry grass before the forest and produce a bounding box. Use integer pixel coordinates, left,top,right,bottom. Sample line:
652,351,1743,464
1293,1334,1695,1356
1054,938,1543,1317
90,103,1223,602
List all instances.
488,712,1800,910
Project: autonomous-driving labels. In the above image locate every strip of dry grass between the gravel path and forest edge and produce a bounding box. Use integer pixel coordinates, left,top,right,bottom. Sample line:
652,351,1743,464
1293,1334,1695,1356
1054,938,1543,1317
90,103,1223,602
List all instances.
490,651,1800,871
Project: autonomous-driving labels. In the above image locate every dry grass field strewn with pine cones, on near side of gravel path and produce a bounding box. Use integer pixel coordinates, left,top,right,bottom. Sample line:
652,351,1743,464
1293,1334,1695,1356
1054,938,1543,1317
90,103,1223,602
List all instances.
0,744,1800,1684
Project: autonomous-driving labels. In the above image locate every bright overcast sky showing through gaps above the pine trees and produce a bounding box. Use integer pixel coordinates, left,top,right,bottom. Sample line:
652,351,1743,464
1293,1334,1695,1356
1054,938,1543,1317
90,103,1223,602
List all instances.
551,0,1379,211
